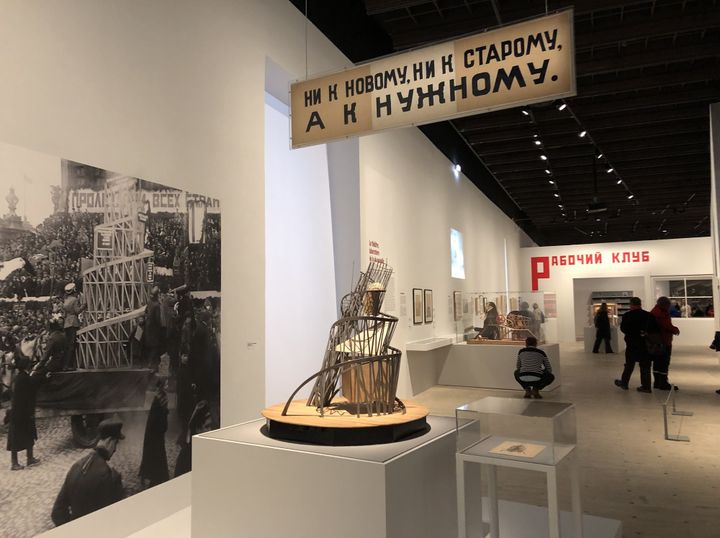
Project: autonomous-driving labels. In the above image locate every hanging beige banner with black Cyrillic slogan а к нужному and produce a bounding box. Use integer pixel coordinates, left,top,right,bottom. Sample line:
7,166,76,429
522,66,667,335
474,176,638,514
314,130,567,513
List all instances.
290,9,576,148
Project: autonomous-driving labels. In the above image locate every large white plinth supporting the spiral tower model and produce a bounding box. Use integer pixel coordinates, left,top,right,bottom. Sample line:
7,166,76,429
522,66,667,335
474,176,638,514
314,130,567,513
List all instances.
192,417,479,538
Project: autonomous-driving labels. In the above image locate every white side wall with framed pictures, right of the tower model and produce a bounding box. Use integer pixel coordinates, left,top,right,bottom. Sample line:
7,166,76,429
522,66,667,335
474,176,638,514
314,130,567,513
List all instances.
360,125,527,397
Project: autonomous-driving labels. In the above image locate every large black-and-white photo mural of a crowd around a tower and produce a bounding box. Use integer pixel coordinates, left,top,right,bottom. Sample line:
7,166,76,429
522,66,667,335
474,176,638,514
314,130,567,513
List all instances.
0,140,221,537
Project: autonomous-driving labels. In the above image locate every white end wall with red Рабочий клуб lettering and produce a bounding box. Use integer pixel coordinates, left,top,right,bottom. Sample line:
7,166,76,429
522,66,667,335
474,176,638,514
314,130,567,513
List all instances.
521,237,713,345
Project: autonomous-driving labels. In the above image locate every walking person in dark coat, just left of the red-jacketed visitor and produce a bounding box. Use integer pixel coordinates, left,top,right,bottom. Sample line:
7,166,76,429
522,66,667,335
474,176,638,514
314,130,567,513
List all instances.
615,297,655,393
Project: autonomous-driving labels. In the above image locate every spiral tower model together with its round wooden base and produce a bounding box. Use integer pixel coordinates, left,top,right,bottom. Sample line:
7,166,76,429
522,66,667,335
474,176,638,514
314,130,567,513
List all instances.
263,262,427,445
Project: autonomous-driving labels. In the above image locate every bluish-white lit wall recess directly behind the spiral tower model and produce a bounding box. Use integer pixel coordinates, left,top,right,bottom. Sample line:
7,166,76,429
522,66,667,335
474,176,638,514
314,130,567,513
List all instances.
265,95,337,405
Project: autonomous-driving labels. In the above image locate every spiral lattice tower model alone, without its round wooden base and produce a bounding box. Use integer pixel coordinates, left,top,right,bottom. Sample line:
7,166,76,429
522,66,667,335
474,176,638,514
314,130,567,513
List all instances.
283,262,404,416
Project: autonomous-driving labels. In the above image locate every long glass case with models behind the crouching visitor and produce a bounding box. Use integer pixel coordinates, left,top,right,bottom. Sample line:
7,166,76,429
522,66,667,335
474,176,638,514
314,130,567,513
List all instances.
453,291,557,345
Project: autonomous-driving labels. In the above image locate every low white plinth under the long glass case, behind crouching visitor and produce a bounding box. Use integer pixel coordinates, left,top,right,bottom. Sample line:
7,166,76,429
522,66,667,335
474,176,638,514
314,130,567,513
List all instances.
438,343,561,391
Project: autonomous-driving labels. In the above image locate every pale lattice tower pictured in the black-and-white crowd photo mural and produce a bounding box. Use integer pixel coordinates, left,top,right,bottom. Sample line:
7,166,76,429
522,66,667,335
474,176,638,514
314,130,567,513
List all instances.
77,176,153,369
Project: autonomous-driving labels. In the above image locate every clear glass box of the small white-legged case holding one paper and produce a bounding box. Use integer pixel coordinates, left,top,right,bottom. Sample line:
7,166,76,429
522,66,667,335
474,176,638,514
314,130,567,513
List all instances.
455,396,577,465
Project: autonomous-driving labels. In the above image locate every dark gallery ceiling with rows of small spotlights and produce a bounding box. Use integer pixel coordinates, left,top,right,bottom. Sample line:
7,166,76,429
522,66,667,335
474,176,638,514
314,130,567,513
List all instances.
292,0,720,245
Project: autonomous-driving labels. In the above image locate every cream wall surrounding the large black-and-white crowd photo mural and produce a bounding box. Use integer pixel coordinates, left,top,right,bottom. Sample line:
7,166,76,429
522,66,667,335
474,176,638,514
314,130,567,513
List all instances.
0,0,349,536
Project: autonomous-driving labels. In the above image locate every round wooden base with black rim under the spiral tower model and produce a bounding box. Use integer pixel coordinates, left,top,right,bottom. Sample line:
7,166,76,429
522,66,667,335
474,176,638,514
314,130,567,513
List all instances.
262,398,429,446
